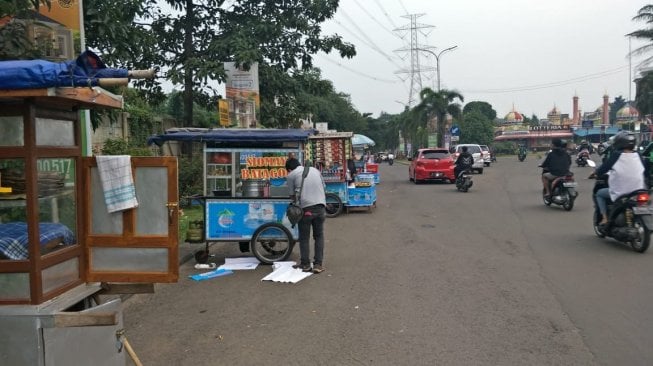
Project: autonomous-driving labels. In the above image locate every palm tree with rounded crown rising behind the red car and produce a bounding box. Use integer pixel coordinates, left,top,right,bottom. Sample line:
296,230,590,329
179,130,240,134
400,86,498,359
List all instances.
413,88,464,146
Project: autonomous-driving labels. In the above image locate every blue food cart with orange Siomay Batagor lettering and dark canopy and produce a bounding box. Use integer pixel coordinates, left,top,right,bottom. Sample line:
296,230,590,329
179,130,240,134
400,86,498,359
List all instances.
150,129,315,264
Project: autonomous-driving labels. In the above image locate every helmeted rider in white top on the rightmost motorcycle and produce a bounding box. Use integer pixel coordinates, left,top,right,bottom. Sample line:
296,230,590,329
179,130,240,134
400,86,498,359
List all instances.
592,131,646,225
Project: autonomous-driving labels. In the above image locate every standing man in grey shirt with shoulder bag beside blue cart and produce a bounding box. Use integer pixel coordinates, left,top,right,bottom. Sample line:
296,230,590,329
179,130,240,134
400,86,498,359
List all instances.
286,158,326,273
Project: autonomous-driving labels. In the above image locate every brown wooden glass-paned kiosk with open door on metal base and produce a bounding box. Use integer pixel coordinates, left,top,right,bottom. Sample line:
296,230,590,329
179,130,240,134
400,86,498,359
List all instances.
0,87,179,365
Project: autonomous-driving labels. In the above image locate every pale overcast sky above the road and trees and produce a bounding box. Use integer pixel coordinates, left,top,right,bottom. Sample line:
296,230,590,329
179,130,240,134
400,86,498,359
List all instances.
315,0,647,119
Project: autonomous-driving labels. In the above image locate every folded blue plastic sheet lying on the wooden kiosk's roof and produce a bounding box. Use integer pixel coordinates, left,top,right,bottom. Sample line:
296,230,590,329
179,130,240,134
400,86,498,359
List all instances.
0,51,129,89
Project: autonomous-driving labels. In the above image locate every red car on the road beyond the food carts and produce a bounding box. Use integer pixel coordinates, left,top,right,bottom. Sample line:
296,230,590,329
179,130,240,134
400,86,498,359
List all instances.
408,147,456,184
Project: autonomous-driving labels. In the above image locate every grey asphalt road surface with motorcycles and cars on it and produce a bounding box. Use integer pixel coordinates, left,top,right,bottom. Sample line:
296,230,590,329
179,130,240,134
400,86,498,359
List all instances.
123,155,653,365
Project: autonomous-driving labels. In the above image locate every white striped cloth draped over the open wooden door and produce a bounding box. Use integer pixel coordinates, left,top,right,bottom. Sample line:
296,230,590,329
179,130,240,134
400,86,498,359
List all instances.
95,155,138,213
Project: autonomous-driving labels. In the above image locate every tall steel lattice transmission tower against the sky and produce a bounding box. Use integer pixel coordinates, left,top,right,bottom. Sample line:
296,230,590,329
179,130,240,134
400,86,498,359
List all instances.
395,13,435,107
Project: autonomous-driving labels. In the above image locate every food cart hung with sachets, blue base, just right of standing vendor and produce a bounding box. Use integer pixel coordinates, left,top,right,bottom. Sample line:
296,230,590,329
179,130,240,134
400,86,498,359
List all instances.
306,132,376,217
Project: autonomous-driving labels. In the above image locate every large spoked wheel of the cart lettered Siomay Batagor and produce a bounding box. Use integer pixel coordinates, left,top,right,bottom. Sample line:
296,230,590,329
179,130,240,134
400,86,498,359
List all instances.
250,222,295,264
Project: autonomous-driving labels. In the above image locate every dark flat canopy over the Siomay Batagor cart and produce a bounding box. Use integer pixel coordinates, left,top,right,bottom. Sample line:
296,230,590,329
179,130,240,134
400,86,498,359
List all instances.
147,128,317,146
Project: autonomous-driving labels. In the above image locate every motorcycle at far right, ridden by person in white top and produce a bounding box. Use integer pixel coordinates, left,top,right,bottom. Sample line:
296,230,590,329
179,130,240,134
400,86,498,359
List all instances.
590,164,653,253
